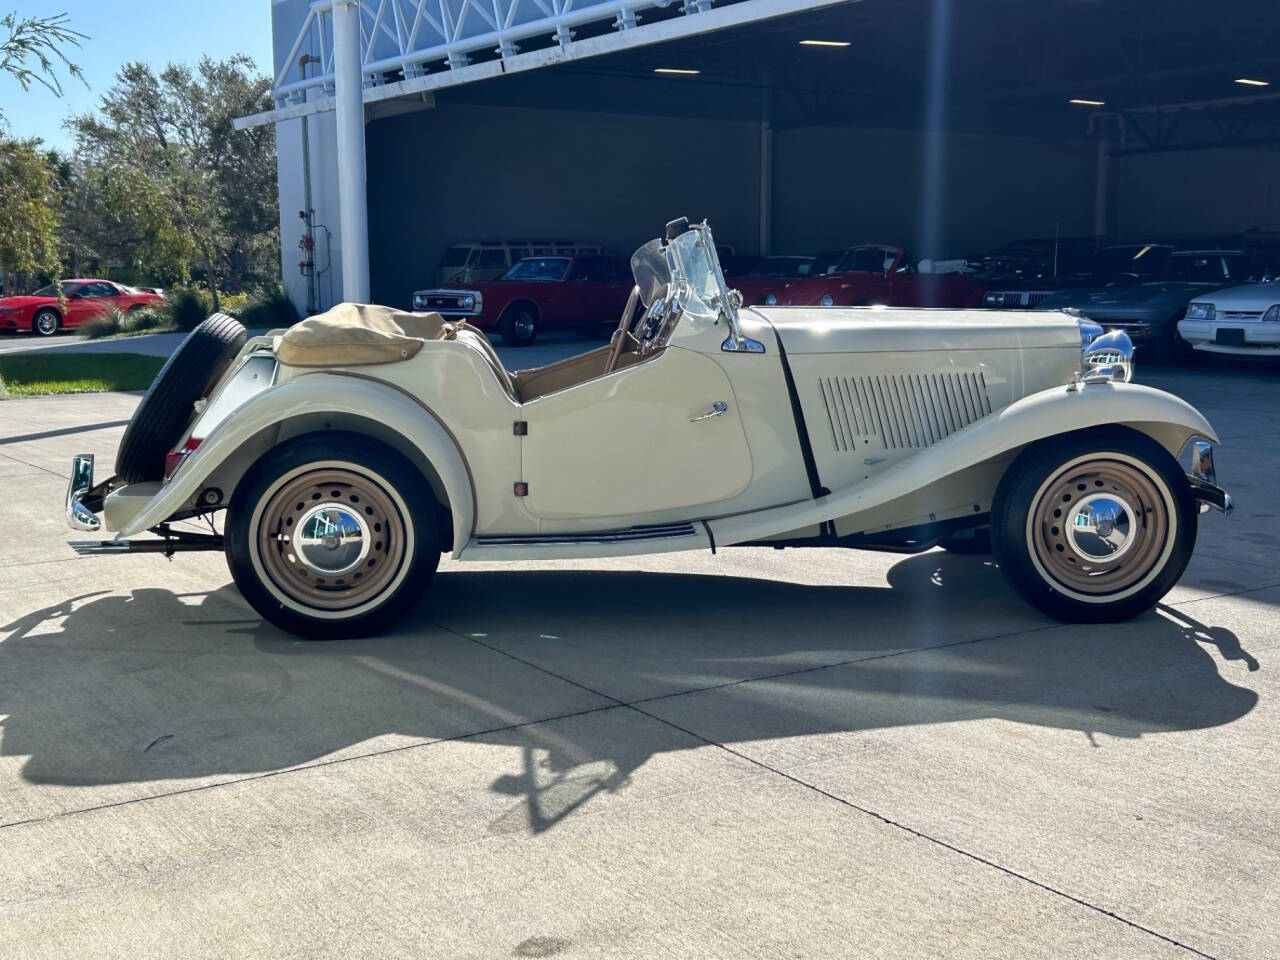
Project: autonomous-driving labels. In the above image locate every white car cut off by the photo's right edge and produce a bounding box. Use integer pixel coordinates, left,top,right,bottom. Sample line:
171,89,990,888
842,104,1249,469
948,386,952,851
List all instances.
1178,282,1280,357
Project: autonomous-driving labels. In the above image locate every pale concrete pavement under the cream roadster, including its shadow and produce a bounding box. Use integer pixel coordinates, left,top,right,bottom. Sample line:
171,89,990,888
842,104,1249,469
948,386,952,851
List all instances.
0,360,1280,960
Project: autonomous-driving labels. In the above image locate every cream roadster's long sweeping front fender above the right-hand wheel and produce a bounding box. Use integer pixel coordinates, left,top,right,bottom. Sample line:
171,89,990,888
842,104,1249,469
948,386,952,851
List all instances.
709,383,1217,545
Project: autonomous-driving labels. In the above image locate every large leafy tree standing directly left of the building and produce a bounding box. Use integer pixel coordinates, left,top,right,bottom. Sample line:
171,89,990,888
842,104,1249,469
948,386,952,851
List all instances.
69,56,279,308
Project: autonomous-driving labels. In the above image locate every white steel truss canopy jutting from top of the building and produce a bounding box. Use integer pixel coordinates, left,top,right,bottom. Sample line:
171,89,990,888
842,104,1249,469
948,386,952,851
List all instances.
236,0,847,129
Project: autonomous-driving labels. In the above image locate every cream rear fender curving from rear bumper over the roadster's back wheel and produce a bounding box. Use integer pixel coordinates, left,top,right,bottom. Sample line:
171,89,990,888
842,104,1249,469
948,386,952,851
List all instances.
118,374,475,556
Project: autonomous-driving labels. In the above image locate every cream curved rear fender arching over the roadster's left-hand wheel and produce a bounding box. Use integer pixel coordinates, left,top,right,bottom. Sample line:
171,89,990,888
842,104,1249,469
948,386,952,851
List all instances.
118,374,475,556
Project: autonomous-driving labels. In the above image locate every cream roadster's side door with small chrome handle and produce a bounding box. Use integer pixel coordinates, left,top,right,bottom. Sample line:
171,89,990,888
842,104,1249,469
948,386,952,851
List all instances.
521,347,751,530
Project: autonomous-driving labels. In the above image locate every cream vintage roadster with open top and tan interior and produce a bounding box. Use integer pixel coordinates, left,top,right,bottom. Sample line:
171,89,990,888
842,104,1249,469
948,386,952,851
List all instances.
67,219,1231,639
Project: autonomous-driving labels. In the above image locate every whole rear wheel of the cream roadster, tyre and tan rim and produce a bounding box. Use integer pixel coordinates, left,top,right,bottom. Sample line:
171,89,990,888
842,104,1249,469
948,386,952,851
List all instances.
225,440,440,640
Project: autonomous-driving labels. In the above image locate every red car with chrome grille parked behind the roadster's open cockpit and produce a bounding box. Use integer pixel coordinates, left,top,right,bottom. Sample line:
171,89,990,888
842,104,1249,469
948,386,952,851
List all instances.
413,255,634,347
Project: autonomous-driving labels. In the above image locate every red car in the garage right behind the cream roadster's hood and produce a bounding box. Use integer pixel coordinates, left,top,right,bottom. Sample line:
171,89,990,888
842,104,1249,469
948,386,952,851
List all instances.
755,243,983,307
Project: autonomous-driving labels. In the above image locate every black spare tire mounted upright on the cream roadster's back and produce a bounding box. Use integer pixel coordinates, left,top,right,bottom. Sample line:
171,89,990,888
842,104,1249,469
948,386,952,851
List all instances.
115,314,246,484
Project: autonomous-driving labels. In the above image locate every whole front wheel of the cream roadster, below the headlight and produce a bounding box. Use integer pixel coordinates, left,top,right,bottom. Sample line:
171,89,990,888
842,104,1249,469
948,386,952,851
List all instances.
991,428,1197,622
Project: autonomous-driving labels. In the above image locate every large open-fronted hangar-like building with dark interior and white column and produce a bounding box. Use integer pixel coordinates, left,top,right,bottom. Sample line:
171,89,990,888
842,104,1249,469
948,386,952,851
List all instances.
238,0,1280,310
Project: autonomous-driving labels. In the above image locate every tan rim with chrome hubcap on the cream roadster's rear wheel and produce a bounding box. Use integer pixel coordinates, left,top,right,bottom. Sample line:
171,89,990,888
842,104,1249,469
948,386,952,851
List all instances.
256,467,407,611
